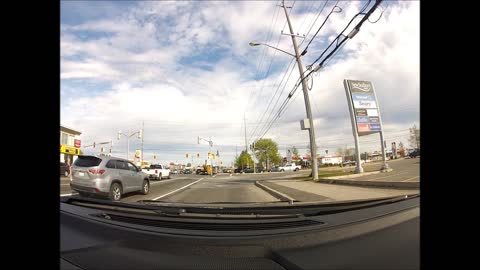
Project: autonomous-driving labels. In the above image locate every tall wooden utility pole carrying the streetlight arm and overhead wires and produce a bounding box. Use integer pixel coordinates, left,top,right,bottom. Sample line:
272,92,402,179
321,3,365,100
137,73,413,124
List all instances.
282,1,318,180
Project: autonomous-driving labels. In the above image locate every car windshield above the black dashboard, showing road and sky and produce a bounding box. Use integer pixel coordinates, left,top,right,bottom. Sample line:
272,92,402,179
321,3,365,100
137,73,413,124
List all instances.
59,0,421,207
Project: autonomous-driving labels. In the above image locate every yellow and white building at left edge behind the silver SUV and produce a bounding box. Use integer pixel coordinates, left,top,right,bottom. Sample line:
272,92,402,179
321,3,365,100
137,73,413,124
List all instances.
60,126,82,165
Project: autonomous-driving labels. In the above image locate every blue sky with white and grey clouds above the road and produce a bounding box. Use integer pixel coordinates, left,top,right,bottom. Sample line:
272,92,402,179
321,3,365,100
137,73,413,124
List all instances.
60,1,420,165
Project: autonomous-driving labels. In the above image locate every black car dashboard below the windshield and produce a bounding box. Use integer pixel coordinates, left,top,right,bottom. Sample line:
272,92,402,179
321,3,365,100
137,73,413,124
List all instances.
60,197,420,269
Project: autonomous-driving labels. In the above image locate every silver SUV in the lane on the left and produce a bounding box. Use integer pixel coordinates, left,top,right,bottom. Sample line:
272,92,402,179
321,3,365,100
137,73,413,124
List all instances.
70,155,150,201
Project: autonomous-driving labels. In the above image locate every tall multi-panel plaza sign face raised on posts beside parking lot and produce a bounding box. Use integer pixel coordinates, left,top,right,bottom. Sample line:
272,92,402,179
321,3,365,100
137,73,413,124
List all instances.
345,80,382,136
